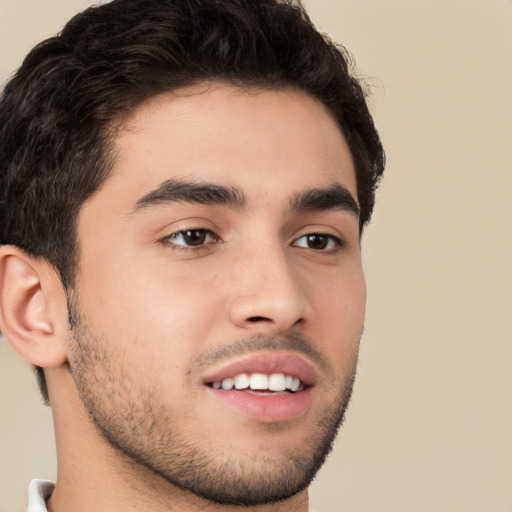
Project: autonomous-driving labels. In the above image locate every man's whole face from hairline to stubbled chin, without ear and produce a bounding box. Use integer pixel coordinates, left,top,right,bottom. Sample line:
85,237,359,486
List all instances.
69,84,365,505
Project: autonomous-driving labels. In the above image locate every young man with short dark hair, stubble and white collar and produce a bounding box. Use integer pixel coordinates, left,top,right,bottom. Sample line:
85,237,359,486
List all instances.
0,0,384,512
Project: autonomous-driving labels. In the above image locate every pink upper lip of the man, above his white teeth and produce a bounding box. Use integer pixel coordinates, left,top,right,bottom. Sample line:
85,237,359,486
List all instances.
203,350,318,387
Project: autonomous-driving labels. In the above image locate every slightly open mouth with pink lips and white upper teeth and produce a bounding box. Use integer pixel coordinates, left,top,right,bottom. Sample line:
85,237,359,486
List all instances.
203,351,317,423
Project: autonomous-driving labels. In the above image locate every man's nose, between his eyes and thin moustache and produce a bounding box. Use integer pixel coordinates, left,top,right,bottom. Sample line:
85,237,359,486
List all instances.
229,243,313,334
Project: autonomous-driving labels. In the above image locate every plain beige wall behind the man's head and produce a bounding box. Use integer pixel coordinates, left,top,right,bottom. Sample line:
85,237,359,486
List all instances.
0,0,512,512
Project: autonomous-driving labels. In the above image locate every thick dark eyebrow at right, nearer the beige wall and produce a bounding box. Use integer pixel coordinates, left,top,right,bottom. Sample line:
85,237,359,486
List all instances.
291,183,360,219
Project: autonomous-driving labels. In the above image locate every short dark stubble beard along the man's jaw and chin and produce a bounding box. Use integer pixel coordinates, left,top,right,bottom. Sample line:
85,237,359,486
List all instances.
66,302,357,506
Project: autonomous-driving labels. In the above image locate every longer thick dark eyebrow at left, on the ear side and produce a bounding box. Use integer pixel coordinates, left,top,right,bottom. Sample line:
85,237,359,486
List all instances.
132,179,247,213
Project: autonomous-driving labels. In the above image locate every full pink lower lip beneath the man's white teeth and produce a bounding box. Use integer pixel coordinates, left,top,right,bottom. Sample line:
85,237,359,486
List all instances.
206,387,312,423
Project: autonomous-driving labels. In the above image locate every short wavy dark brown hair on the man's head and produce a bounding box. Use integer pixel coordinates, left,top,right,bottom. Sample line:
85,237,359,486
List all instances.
0,0,384,401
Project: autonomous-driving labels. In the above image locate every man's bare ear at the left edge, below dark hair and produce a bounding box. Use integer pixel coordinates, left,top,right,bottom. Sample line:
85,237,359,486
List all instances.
0,245,67,368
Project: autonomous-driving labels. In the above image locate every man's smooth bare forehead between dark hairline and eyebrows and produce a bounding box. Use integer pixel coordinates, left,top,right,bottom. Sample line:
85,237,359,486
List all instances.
89,83,357,214
